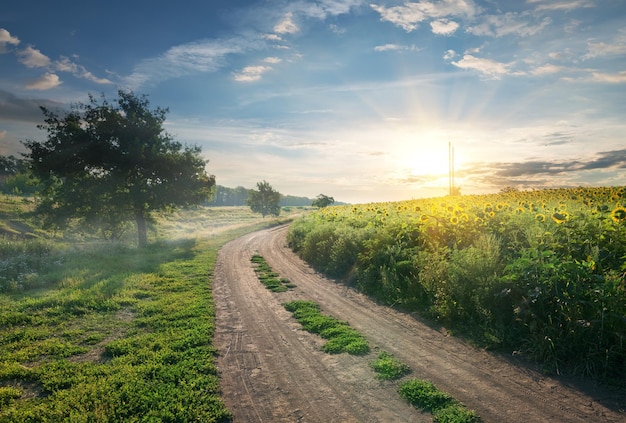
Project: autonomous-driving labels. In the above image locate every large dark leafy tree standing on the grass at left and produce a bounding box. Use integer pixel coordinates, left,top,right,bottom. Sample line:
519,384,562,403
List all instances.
24,90,215,246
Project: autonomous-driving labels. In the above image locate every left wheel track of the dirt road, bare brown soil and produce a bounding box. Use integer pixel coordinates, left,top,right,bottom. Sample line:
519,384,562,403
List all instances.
213,231,424,423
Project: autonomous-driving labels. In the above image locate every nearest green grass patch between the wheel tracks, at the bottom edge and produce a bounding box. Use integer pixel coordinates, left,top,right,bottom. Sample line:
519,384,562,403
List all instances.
398,379,481,423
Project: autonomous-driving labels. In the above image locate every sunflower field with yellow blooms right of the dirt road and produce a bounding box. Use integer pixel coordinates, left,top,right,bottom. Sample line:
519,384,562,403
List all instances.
288,187,626,387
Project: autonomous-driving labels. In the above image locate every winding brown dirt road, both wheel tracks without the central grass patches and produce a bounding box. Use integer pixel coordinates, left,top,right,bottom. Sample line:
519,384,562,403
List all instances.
213,227,626,423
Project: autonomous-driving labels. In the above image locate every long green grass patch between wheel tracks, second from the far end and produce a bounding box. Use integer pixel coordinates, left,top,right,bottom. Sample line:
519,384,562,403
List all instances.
283,300,370,355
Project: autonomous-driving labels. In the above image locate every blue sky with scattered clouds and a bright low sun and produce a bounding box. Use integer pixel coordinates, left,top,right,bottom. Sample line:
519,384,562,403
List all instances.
0,0,626,203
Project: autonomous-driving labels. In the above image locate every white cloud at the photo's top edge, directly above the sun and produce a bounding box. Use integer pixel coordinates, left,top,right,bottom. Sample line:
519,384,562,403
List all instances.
370,0,478,32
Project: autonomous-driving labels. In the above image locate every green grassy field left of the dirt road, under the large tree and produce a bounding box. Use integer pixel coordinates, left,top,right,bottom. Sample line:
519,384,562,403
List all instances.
0,197,302,422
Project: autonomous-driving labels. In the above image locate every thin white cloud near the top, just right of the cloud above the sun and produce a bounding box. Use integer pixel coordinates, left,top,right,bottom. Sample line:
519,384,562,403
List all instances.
467,12,552,37
